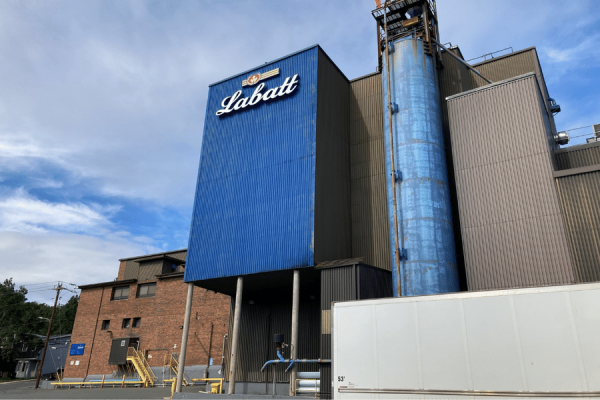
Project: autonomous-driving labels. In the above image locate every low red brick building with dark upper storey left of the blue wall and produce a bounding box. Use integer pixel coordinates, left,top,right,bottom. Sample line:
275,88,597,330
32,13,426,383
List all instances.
65,250,230,378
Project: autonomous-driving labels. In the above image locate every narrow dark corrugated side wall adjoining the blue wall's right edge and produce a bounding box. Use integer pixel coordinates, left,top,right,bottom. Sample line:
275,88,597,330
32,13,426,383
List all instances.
315,49,352,263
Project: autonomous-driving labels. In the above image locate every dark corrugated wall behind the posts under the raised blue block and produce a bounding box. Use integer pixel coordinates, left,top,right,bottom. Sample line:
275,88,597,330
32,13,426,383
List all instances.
225,292,321,383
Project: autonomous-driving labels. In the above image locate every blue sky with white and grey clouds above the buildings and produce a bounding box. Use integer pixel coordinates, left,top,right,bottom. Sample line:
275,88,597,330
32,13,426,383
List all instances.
0,0,600,303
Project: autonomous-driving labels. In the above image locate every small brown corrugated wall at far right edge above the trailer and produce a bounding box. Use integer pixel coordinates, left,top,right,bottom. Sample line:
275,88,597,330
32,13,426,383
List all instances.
556,172,600,282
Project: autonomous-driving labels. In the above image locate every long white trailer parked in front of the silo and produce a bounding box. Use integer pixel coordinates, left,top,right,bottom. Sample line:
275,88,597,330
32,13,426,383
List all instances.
332,283,600,399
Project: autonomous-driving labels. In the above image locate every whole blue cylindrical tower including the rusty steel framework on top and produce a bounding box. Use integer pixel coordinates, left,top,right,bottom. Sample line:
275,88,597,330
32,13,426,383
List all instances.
373,0,459,296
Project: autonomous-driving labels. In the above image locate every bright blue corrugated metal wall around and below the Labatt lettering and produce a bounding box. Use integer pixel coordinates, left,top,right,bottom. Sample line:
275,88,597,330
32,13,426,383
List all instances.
185,47,318,282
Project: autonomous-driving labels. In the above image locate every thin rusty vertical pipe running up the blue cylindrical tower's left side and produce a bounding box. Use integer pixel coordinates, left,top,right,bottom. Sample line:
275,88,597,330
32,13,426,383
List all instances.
380,0,402,297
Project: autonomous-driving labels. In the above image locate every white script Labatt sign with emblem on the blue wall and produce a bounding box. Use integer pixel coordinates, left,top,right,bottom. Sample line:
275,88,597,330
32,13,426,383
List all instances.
216,68,298,116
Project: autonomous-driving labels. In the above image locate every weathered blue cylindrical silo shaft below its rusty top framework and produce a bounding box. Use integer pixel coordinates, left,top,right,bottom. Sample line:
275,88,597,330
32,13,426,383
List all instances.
383,39,459,296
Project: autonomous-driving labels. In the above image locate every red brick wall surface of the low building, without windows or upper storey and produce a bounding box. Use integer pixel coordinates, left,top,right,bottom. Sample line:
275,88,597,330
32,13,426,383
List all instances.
65,277,230,378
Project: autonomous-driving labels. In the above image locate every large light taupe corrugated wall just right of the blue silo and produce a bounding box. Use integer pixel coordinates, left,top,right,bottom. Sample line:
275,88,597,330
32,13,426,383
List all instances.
448,75,575,290
